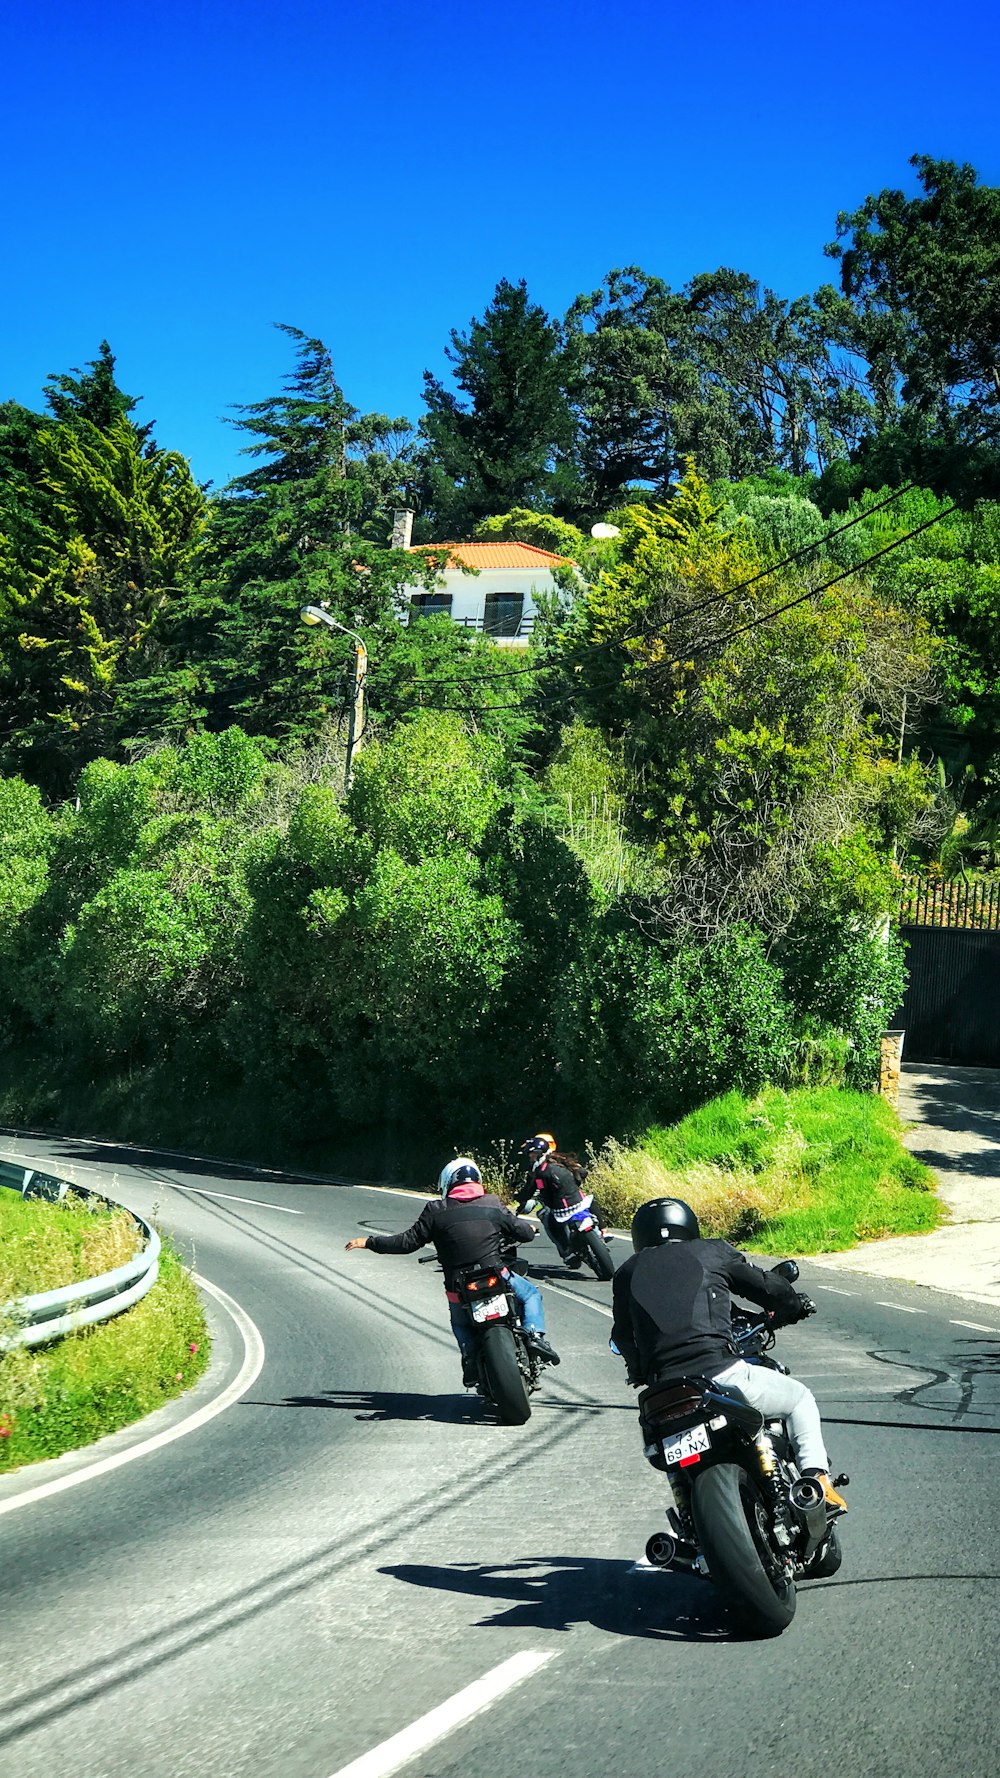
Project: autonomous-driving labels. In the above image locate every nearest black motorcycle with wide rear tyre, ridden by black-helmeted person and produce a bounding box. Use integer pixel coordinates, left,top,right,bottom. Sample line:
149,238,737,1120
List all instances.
639,1261,849,1636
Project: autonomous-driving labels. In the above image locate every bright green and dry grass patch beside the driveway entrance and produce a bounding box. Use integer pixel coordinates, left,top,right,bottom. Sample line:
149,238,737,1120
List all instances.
589,1086,945,1253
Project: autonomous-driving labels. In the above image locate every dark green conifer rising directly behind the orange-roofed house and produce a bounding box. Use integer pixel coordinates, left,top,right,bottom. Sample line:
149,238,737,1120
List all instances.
423,279,571,542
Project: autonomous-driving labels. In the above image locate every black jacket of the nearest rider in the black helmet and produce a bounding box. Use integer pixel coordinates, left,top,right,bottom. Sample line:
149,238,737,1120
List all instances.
612,1241,802,1383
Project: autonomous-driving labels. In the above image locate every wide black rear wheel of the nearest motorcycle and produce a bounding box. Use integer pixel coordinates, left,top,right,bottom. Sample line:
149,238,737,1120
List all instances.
690,1463,795,1636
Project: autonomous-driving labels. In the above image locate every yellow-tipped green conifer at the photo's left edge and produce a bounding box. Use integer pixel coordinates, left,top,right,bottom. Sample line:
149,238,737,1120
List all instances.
0,387,205,789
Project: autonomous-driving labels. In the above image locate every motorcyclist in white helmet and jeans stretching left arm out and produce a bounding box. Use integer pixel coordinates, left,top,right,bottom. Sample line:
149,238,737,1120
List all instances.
347,1154,559,1389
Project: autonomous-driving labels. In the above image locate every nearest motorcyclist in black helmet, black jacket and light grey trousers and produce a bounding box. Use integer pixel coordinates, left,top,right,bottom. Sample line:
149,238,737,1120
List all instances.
612,1198,847,1511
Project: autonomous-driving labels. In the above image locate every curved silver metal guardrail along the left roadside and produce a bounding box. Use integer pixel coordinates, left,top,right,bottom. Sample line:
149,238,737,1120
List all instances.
0,1161,160,1351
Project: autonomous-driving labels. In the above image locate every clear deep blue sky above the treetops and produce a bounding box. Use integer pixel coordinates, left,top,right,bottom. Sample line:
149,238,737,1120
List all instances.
0,0,1000,482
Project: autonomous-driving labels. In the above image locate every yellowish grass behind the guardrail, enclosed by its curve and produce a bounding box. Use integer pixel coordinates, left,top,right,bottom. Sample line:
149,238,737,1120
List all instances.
0,1191,142,1303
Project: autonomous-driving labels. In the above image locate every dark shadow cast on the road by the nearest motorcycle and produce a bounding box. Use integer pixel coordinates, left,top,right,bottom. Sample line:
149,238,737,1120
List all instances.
379,1556,735,1643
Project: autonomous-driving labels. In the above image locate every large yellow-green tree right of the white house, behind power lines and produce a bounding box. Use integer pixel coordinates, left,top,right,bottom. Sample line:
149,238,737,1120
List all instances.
569,466,929,933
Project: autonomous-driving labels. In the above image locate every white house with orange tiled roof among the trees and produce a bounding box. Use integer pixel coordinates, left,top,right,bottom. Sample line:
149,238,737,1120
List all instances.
395,529,573,647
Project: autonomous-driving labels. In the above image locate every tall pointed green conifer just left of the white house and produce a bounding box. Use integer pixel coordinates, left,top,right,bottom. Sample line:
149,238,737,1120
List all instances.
121,327,434,741
